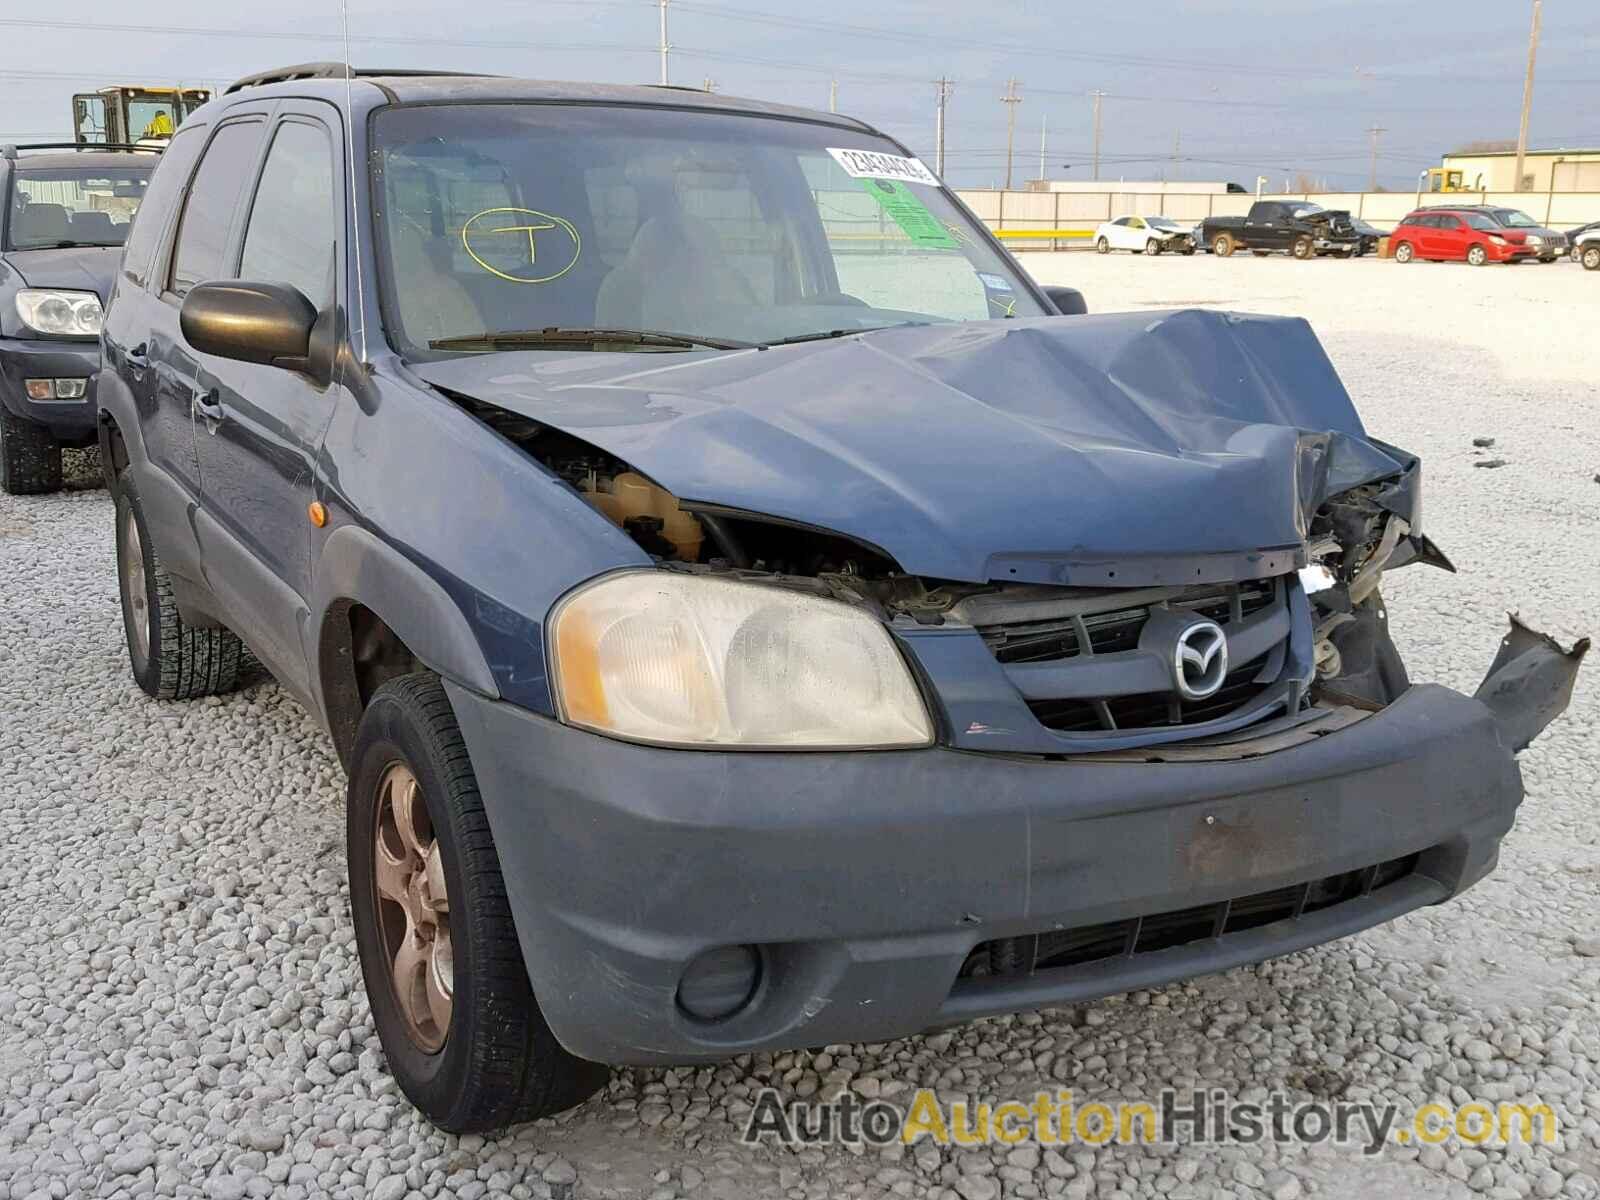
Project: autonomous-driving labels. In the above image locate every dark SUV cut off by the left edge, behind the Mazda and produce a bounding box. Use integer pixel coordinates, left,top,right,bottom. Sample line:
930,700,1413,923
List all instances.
0,144,155,494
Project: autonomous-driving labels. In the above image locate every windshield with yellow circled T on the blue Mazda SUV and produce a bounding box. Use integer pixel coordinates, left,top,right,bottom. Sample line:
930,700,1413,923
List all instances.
374,104,1045,357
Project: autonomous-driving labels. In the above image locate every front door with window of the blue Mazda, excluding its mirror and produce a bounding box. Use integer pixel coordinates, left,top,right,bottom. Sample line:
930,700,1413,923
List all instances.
195,101,342,693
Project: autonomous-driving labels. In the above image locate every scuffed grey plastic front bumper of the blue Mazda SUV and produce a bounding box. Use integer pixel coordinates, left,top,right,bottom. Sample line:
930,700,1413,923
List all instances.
448,678,1536,1064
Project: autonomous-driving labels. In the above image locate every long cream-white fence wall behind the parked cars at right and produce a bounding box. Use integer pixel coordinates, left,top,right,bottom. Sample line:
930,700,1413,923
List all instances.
957,187,1600,250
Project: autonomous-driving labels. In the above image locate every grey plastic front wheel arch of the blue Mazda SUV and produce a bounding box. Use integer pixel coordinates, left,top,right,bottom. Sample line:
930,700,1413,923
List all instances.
312,525,499,765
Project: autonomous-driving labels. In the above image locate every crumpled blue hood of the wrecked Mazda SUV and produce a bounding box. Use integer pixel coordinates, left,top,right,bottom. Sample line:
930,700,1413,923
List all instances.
414,310,1408,586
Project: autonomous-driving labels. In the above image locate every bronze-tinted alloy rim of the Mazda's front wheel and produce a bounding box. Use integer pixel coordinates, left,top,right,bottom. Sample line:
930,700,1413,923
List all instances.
373,763,456,1054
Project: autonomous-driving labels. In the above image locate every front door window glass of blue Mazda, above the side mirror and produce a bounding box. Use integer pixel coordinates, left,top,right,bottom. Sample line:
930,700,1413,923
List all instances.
238,122,336,309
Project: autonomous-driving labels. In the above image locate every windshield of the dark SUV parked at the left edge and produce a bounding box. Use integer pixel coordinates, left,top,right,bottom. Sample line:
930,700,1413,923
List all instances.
6,166,150,250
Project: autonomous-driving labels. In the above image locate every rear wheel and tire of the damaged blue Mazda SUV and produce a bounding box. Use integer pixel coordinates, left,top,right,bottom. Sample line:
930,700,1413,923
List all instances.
117,480,253,699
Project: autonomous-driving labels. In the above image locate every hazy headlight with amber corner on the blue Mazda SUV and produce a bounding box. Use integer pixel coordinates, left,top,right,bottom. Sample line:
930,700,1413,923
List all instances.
550,571,933,749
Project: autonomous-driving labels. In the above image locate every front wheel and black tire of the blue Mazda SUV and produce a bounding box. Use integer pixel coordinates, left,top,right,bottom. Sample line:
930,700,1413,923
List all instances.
346,674,606,1133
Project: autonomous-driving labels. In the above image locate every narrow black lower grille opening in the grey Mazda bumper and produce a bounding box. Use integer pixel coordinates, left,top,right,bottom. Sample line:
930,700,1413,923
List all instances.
960,854,1421,979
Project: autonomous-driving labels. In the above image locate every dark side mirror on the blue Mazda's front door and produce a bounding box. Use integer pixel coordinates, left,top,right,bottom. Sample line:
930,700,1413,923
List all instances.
178,280,317,371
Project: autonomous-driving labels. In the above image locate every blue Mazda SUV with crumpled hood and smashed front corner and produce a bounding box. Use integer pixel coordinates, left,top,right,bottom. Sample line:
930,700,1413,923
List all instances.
98,66,1582,1130
